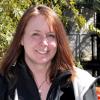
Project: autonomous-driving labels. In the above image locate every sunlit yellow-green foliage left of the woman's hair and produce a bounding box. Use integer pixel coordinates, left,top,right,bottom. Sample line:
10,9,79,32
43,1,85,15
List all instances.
0,0,31,58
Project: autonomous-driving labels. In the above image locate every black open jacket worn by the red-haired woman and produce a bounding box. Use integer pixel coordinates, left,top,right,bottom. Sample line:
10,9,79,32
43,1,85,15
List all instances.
0,60,97,100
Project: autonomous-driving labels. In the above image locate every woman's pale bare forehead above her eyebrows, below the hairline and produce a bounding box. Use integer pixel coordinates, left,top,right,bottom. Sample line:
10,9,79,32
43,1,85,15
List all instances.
25,15,53,31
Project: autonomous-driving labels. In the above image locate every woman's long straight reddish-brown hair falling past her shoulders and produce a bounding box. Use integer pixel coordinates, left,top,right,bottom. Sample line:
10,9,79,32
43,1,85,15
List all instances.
1,5,74,79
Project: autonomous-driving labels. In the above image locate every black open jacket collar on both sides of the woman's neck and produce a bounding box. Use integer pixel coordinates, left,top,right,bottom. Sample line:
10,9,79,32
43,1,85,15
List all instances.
16,59,71,100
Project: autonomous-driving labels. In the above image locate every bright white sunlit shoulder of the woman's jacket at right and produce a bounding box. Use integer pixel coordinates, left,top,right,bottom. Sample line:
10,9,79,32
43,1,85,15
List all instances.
73,67,96,97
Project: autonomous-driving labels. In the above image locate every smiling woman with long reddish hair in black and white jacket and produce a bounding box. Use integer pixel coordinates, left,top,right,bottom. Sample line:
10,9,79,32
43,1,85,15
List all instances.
0,5,97,100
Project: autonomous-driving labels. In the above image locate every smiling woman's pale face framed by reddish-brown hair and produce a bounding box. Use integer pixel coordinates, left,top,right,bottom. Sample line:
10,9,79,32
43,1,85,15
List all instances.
21,15,57,64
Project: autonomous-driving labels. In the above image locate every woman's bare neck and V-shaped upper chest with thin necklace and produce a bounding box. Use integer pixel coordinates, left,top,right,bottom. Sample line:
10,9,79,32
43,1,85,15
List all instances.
26,57,51,100
